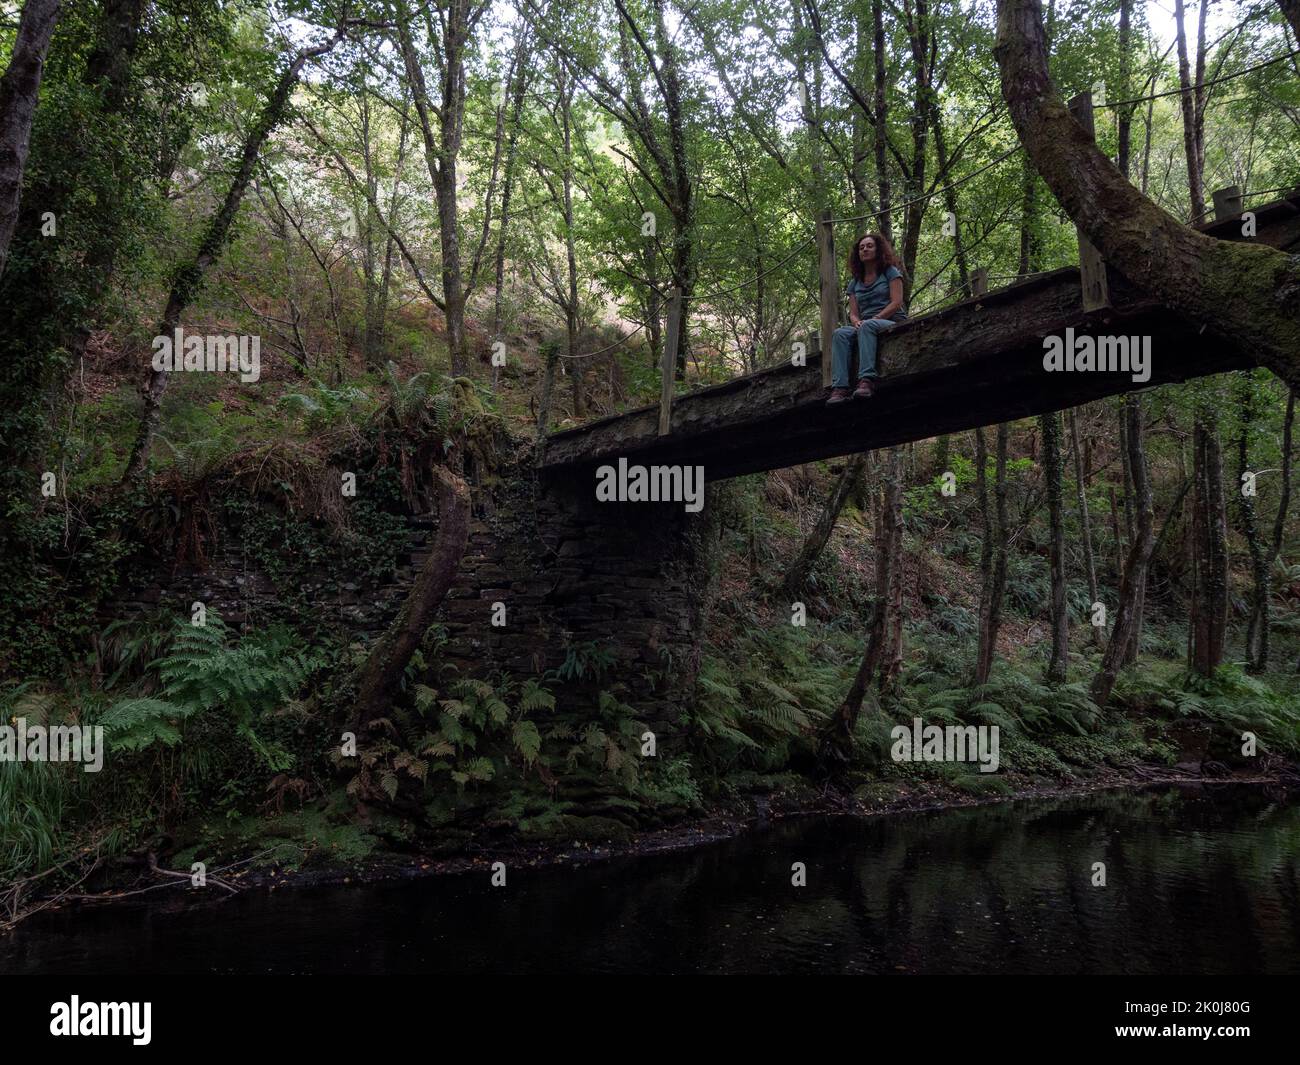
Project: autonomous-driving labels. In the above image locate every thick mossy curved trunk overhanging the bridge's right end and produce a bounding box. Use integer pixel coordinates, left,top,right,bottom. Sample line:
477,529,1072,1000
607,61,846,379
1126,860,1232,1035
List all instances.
995,0,1300,388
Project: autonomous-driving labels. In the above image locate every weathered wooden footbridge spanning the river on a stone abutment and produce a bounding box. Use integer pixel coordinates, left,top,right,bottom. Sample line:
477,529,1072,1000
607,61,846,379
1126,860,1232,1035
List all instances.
542,190,1300,481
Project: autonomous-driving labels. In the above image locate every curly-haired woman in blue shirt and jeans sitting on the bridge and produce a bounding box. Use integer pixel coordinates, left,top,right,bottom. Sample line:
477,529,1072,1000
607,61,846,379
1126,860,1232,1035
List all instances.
826,233,907,404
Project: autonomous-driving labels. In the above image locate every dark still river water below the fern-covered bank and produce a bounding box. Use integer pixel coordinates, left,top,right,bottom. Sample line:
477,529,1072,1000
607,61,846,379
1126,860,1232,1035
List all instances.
0,785,1300,974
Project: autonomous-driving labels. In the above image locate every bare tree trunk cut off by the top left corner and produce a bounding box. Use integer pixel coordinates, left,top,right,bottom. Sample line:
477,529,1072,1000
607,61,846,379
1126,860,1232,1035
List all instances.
0,0,60,276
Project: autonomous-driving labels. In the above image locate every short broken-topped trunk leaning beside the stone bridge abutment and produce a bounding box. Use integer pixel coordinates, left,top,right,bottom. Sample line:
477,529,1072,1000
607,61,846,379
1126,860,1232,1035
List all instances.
352,466,469,735
